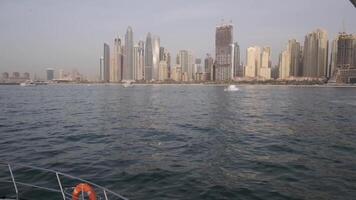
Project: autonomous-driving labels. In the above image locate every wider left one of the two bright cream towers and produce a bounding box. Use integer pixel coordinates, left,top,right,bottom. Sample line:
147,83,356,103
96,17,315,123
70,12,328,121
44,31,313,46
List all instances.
245,46,261,78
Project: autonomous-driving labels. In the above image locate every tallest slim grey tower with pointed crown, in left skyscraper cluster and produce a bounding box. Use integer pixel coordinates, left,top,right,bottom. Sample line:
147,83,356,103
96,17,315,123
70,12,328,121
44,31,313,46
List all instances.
122,26,134,80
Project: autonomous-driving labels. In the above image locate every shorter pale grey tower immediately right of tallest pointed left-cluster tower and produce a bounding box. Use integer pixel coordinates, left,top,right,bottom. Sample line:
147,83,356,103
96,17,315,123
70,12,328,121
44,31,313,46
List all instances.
133,41,144,80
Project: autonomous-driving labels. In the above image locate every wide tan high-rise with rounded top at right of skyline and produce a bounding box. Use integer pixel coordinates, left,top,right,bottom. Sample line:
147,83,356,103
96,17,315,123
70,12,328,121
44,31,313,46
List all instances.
303,29,328,78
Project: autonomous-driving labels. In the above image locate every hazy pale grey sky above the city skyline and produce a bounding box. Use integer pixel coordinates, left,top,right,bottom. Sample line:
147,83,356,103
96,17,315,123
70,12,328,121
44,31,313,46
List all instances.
0,0,356,77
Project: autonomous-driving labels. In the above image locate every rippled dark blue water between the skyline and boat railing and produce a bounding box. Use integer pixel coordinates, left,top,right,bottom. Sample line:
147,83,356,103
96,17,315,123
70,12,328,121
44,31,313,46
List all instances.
0,85,356,199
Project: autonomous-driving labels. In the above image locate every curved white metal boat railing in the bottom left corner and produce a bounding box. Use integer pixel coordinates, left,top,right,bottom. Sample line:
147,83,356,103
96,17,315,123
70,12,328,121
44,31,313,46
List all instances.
0,162,128,200
